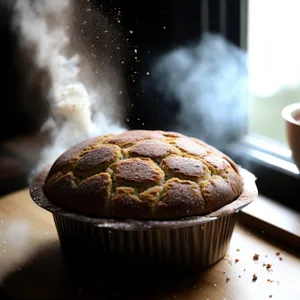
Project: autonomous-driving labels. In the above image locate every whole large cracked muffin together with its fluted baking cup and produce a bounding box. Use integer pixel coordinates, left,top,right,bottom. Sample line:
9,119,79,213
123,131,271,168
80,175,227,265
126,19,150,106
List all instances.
31,130,257,268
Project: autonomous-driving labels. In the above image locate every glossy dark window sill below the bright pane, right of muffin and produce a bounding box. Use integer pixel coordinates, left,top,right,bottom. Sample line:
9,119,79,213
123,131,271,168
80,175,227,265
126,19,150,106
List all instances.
224,133,300,212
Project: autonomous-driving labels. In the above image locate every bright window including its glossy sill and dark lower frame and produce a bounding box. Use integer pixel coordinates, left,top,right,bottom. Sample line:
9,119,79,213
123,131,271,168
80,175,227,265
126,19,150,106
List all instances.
228,0,300,209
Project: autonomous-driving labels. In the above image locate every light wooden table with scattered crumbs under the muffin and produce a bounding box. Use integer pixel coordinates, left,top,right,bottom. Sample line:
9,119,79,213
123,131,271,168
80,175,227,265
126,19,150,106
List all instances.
0,189,300,300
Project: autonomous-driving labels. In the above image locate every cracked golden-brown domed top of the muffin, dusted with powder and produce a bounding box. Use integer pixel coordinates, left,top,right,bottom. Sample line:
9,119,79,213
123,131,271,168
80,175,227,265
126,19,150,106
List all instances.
44,130,243,220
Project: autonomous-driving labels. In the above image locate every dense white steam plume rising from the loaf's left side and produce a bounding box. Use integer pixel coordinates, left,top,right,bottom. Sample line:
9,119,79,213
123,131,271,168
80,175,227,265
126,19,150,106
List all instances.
14,0,123,173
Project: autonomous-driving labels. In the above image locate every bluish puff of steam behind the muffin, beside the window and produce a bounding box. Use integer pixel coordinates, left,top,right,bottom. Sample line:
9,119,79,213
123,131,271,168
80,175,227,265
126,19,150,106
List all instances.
145,34,248,149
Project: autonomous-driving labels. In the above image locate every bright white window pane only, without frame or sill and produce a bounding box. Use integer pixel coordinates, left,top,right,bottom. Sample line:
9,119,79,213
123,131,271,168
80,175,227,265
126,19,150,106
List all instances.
247,0,300,144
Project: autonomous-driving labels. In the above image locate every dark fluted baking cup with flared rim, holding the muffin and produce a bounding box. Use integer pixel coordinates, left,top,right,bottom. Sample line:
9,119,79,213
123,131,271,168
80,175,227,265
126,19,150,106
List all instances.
30,169,258,271
